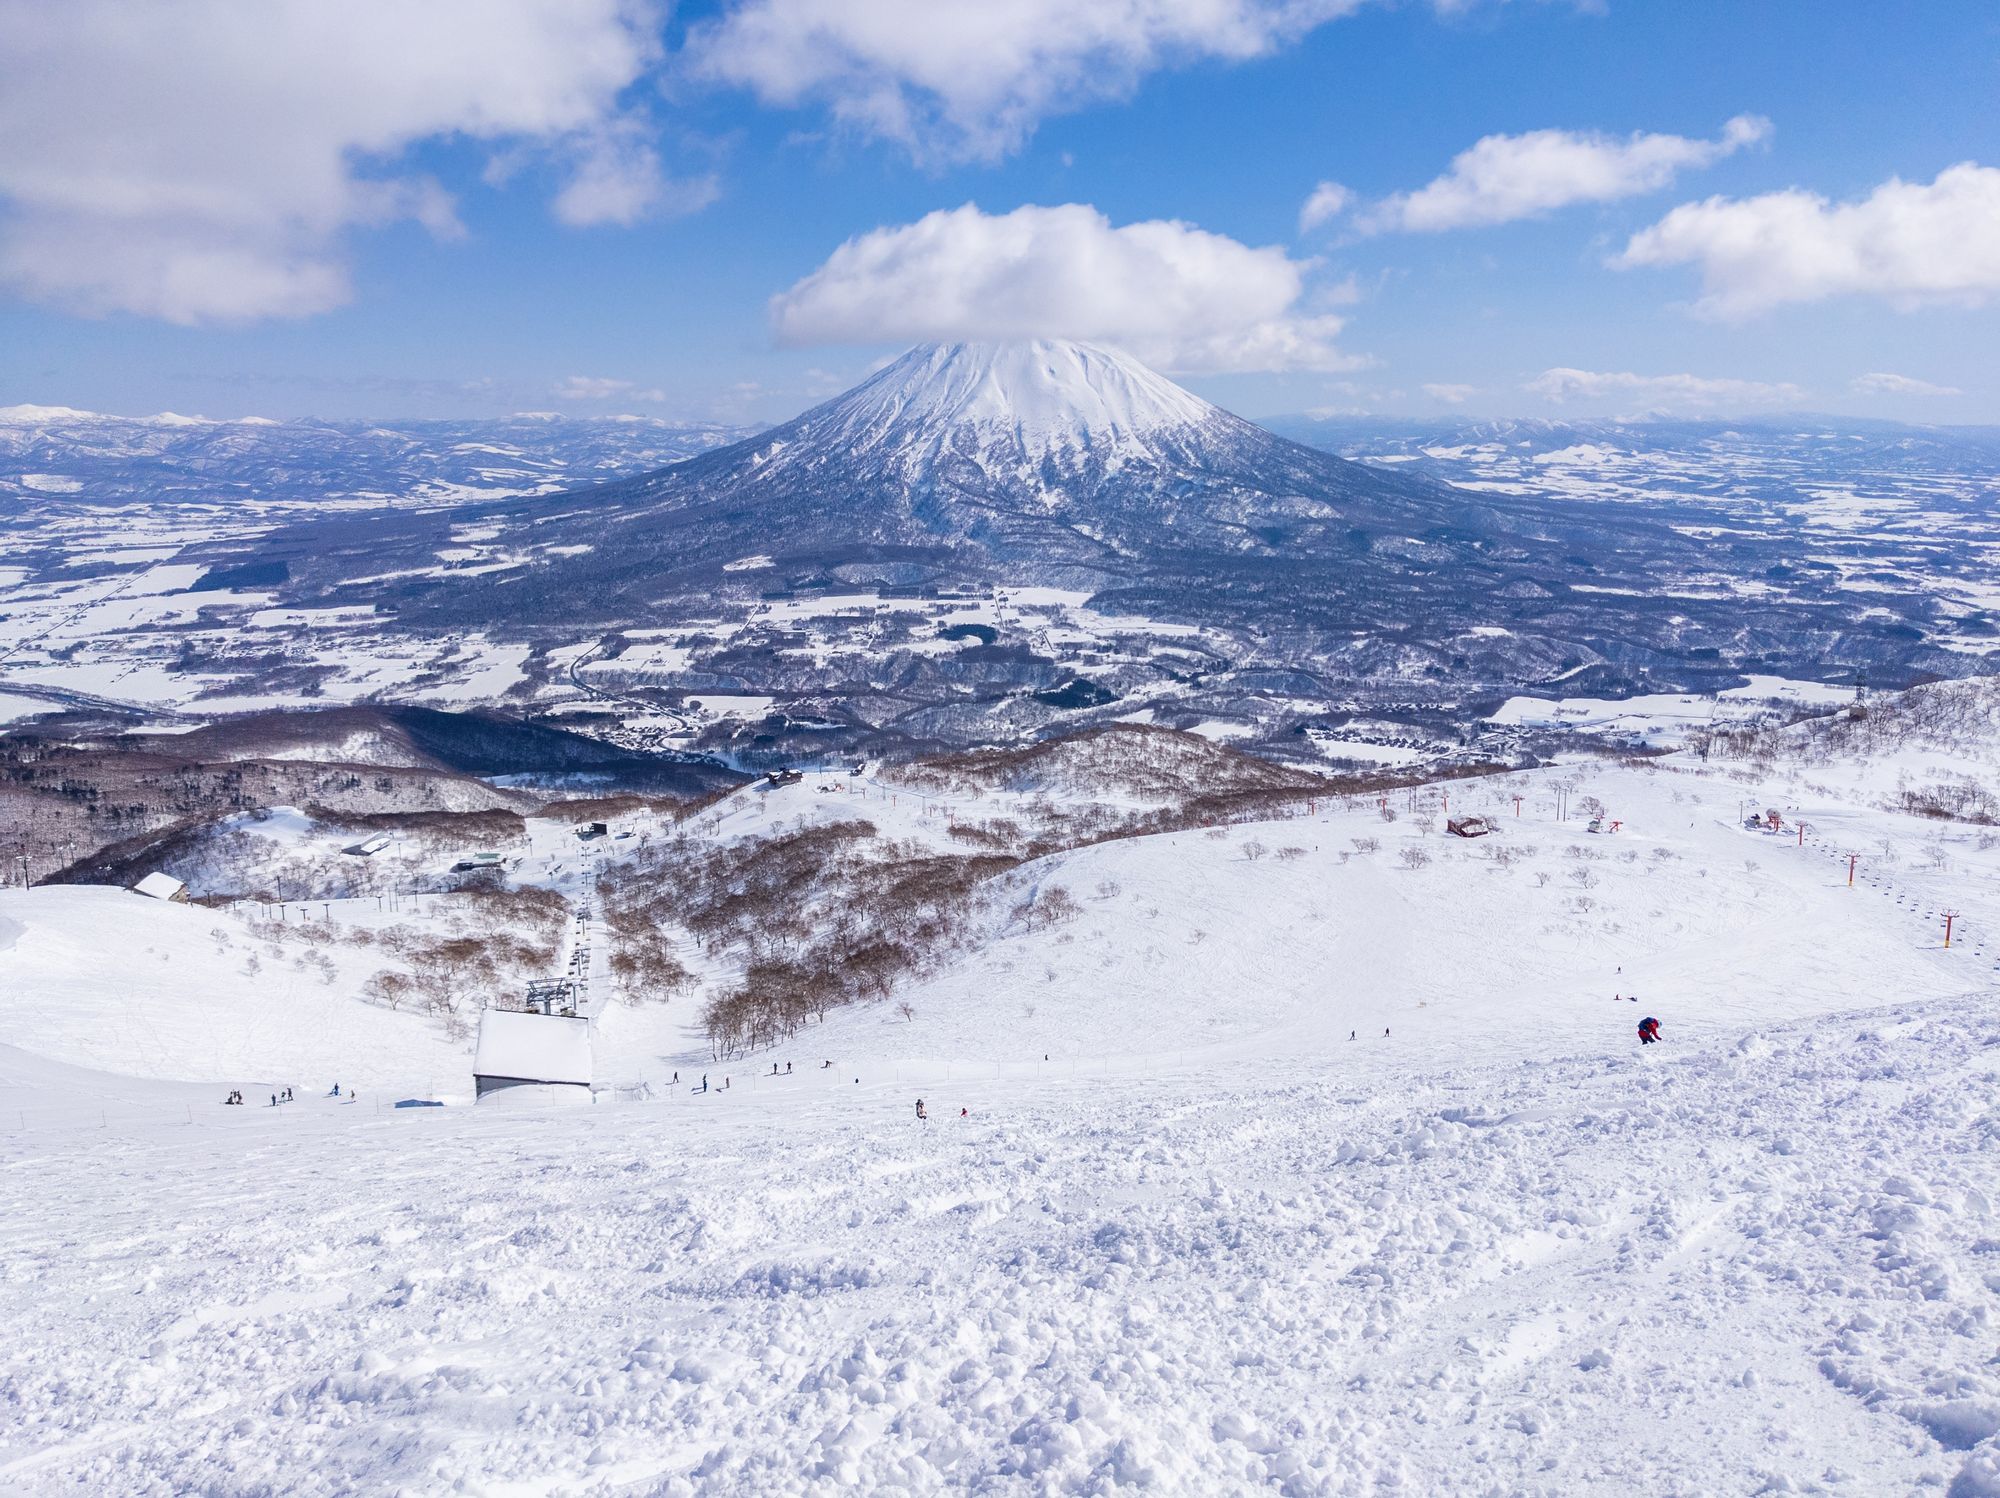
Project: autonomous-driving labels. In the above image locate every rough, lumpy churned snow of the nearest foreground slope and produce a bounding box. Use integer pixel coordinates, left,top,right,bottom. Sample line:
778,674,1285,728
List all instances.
0,1004,2000,1498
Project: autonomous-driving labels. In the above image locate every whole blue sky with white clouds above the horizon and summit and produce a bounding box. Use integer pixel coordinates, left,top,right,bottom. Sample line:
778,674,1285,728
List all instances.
0,0,2000,422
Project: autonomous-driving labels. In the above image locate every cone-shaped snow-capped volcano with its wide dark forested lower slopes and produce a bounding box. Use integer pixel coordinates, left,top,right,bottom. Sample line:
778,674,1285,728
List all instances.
223,342,1968,680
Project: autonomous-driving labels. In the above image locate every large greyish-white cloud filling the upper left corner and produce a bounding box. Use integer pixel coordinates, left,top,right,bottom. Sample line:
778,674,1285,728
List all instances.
0,0,672,322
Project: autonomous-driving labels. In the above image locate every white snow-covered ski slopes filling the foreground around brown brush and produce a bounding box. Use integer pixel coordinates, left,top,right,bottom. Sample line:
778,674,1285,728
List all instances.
0,740,2000,1498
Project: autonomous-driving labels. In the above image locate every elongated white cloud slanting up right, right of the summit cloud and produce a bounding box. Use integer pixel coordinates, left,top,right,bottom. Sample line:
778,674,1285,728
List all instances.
1360,114,1770,234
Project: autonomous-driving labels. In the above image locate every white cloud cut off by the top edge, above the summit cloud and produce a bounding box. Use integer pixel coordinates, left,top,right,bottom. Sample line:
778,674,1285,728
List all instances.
686,0,1362,160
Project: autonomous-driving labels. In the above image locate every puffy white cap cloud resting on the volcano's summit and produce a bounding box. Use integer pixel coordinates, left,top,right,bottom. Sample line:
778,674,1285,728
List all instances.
772,204,1362,372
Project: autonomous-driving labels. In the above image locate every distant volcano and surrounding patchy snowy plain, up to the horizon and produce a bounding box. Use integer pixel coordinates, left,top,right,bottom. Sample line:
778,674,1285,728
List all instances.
0,342,2000,754
